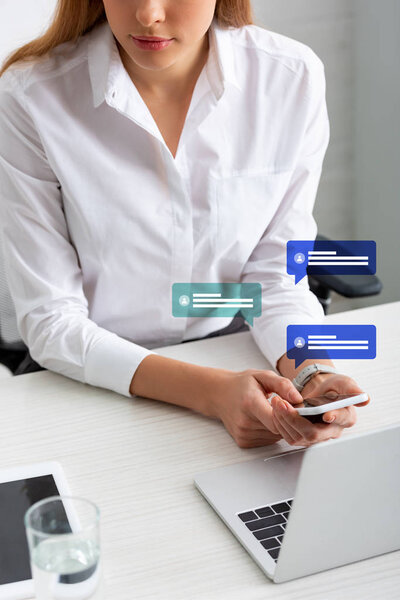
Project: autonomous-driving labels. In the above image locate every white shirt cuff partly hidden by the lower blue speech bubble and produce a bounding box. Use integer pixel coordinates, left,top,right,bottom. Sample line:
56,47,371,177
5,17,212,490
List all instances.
251,306,325,372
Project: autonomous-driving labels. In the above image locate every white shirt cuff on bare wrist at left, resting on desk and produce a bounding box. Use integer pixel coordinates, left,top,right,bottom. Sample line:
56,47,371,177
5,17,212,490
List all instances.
85,333,157,398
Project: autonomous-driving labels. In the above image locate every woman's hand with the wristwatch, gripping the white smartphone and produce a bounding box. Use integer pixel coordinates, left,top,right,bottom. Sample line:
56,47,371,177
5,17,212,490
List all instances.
271,373,370,446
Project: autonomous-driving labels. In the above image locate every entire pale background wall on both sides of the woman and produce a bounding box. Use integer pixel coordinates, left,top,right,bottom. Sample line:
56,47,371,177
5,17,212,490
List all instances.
0,0,400,312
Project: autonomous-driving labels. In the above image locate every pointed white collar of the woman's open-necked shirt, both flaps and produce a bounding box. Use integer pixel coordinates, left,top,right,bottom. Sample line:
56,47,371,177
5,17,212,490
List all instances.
88,17,241,108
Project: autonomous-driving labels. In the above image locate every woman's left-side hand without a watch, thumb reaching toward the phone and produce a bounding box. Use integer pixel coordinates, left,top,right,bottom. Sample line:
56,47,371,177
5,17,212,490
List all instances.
210,369,303,448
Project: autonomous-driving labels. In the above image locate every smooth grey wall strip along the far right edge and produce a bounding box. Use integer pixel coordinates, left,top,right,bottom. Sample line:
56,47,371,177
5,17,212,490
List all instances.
355,0,400,302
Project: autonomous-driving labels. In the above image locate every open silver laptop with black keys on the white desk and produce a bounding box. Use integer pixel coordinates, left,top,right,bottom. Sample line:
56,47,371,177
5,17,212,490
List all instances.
194,424,400,583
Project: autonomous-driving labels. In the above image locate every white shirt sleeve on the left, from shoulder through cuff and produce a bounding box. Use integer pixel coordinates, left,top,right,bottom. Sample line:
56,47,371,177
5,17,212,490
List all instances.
0,71,156,398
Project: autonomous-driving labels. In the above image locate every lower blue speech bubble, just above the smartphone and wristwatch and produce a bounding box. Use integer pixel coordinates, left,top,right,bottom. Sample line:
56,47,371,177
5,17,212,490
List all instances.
286,324,376,368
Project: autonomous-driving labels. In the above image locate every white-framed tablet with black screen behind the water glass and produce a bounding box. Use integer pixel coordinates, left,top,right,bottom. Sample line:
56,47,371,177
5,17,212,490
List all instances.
0,462,71,600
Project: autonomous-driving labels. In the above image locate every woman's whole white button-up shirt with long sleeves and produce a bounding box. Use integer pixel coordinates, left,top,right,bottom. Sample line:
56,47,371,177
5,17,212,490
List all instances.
0,20,329,397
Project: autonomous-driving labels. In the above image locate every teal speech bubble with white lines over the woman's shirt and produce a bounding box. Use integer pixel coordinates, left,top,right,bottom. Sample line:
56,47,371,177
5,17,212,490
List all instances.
172,283,261,326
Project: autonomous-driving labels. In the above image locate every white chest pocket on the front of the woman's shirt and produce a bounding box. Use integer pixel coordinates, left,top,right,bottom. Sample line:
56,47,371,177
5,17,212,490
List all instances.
215,171,292,265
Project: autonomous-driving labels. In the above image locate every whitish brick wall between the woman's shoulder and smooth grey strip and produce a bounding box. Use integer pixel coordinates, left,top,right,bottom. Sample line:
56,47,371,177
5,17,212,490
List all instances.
252,0,357,312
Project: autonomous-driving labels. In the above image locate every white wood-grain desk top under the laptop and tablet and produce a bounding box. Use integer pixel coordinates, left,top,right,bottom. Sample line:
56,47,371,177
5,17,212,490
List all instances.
0,302,400,600
